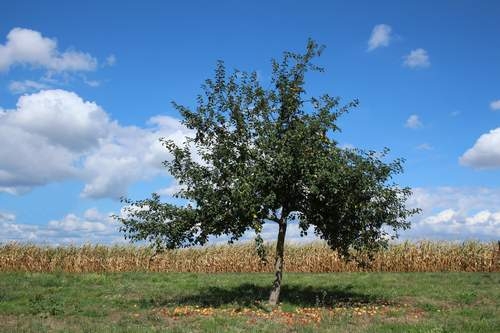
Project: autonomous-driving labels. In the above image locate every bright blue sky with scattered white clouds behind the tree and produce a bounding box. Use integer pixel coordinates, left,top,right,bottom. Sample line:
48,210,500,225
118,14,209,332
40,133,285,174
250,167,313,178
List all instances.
0,0,500,244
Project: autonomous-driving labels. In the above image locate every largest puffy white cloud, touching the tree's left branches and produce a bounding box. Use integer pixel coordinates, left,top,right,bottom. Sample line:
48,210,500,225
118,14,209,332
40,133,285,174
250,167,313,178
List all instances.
0,90,191,198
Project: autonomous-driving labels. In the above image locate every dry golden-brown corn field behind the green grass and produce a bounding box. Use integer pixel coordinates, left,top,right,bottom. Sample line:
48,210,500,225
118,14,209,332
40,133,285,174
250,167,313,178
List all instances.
0,241,500,273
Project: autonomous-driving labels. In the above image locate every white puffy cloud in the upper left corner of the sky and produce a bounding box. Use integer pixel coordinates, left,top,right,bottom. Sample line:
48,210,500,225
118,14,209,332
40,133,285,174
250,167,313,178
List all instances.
0,28,97,72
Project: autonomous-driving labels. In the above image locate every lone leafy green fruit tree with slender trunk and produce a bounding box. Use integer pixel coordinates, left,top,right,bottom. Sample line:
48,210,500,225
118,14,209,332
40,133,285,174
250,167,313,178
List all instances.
118,40,418,305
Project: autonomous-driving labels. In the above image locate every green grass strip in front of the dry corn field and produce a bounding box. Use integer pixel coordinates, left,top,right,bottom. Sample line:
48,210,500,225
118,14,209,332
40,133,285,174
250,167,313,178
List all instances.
0,273,500,333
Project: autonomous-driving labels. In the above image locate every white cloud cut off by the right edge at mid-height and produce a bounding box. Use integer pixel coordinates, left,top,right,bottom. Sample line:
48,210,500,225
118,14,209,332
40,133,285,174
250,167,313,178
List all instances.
459,127,500,169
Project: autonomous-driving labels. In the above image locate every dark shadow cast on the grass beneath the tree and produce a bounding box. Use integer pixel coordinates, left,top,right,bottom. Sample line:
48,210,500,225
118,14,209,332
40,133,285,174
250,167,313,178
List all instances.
141,283,388,307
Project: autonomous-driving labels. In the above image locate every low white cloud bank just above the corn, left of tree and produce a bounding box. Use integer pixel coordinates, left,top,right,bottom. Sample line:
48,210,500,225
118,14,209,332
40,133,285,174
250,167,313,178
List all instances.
0,208,125,245
